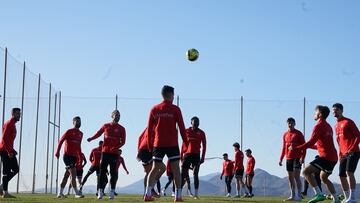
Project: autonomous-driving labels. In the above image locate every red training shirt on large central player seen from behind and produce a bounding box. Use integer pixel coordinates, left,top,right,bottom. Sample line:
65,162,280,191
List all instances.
148,101,187,148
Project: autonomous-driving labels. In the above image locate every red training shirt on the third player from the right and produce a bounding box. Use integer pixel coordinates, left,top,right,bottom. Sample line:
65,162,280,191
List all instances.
280,129,306,161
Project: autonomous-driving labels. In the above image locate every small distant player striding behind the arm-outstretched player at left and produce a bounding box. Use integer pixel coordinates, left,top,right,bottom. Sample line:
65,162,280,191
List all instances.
80,141,104,191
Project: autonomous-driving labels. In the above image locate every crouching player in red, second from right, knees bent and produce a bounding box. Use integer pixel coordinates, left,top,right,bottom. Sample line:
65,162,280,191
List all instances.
289,105,340,203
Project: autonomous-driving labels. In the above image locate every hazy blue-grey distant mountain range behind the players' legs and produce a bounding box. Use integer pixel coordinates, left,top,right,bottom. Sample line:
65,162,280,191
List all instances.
39,169,360,196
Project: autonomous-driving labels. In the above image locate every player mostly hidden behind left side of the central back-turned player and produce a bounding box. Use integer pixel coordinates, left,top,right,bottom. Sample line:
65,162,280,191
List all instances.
137,128,166,198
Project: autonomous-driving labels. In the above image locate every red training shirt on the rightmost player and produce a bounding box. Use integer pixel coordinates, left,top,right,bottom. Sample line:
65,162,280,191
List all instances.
335,117,360,157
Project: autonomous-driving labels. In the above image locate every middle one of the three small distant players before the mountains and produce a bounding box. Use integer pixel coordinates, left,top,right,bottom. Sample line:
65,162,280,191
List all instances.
233,142,248,198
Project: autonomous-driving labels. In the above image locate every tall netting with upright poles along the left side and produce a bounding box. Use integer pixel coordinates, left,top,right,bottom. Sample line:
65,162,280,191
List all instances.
0,47,59,192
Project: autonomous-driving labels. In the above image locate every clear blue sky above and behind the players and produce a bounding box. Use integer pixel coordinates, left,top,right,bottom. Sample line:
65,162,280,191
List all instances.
0,0,360,190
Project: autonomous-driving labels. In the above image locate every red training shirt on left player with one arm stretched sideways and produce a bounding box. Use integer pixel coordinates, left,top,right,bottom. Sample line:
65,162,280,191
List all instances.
90,122,126,154
